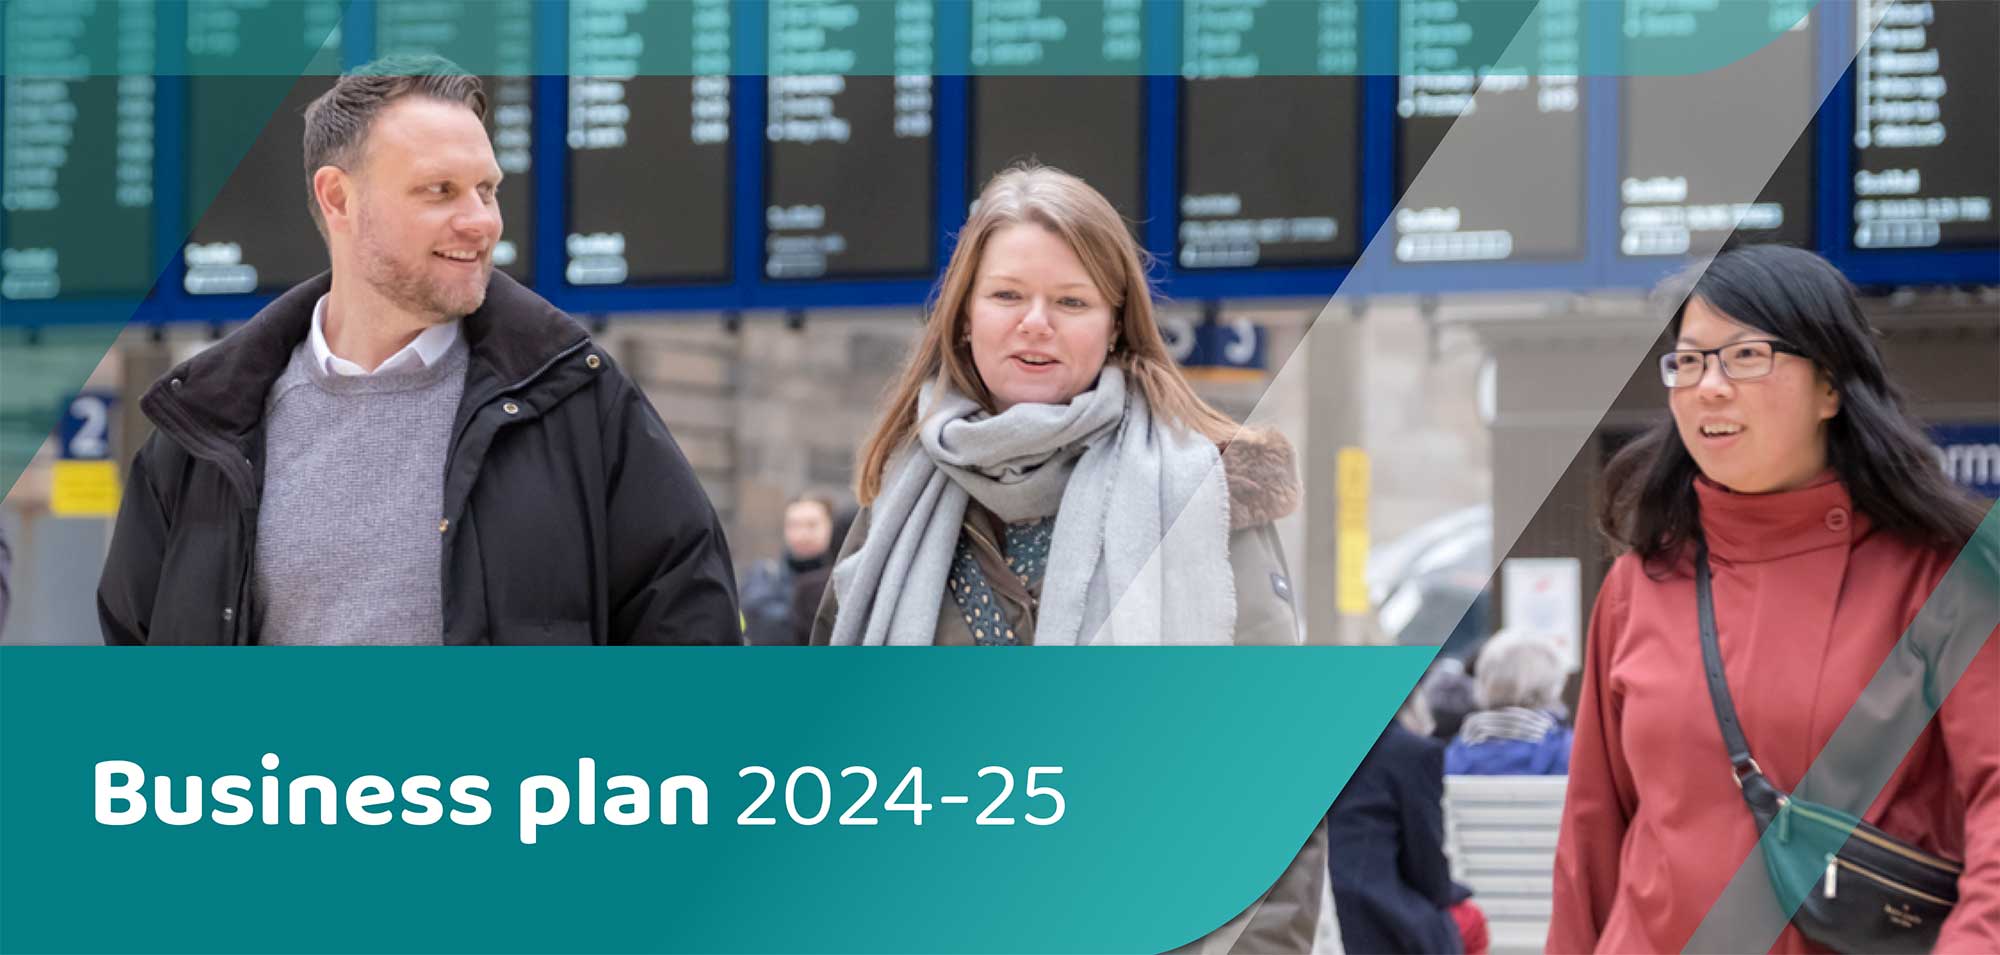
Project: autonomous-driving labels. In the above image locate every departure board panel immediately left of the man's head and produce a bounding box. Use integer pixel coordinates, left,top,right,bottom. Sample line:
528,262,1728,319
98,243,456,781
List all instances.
182,0,342,296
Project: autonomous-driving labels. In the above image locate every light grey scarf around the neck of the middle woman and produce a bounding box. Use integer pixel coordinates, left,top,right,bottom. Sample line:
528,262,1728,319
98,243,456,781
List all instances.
832,366,1236,645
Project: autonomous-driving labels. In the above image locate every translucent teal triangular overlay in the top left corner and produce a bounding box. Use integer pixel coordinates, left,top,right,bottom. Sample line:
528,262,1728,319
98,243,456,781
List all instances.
0,0,348,495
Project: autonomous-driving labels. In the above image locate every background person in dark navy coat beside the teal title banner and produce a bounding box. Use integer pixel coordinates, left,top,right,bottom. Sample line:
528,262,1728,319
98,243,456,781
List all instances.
1326,691,1486,955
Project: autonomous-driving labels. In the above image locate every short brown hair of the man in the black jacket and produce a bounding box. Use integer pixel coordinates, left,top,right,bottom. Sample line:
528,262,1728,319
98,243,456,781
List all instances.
306,56,486,238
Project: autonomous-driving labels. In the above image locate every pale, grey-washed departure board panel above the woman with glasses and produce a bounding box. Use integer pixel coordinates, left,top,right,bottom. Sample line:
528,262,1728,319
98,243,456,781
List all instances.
1618,0,1820,256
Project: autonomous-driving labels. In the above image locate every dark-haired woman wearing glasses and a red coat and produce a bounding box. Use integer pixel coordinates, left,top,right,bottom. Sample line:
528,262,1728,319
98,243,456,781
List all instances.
1548,246,2000,953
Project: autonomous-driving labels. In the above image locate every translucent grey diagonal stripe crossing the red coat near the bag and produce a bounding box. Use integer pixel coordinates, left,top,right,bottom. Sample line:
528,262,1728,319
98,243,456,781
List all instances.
1686,505,2000,953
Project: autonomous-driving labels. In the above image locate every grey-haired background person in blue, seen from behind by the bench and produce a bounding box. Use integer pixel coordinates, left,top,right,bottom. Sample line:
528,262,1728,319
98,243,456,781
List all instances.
1444,631,1570,775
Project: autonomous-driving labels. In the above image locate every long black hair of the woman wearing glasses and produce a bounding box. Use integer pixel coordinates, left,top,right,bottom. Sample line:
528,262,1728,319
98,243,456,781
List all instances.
1598,246,1984,563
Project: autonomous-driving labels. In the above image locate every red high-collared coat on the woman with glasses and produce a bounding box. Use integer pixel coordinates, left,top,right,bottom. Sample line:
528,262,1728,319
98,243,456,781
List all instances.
1548,478,2000,953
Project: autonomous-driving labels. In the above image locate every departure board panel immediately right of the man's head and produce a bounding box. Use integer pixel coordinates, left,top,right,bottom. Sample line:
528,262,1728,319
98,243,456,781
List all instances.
376,0,536,282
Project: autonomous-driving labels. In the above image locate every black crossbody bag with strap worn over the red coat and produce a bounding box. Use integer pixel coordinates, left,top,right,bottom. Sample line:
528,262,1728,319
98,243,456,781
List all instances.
1694,543,1964,953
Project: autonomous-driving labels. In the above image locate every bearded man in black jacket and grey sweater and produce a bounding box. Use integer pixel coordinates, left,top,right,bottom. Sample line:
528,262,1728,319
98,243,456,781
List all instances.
98,58,742,645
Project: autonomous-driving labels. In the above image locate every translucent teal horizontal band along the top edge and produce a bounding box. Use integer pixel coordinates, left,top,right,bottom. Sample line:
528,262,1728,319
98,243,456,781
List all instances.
0,0,1824,78
